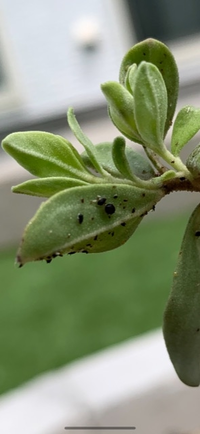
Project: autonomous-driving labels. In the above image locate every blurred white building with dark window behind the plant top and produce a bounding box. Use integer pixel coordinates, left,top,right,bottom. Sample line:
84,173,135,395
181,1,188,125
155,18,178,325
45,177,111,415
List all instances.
0,0,200,135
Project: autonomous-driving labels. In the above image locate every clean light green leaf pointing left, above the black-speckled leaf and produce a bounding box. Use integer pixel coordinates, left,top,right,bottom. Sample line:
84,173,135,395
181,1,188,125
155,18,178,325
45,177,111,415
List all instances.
2,131,91,180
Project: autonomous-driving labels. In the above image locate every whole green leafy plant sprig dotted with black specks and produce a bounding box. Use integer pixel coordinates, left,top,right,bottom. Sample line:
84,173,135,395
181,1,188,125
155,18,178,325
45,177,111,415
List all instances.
2,39,200,386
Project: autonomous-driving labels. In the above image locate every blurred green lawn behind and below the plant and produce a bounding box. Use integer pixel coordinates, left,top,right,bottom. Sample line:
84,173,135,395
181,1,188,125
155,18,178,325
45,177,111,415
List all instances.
0,212,190,393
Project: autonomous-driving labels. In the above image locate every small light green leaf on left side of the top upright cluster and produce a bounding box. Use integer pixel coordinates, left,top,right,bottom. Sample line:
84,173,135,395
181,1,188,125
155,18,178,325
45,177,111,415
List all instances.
101,81,143,144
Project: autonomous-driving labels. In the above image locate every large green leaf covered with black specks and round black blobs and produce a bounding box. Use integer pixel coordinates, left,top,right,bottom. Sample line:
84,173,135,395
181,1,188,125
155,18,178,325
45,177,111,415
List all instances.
17,184,164,266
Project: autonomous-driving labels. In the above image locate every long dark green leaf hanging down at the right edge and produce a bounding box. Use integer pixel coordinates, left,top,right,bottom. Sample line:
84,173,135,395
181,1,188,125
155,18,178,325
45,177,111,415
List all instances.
163,205,200,387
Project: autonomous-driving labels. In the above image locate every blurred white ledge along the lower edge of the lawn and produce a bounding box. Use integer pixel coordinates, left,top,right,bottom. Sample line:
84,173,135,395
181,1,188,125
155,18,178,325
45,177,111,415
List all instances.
0,330,179,434
